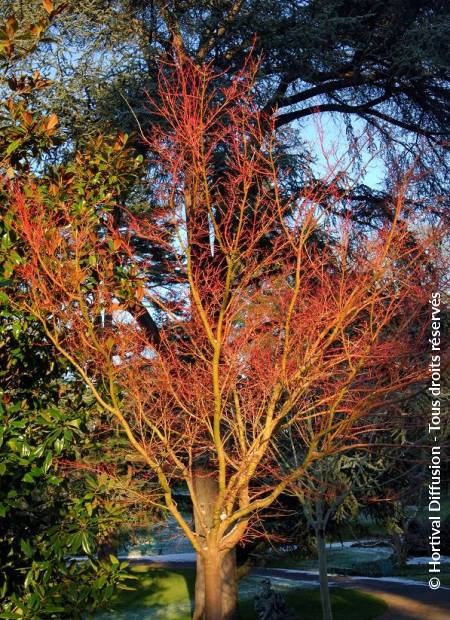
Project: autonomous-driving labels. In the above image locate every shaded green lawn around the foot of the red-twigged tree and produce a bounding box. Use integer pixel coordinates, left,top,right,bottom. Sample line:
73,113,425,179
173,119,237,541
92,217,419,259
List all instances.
94,565,387,620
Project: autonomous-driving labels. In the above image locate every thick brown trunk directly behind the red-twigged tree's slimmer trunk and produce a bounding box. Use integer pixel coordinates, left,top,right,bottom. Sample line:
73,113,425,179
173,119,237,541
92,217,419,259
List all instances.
193,472,238,620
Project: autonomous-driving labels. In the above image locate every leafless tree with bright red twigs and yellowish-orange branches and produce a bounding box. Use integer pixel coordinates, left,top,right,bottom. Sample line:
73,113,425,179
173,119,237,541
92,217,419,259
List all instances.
5,55,442,620
